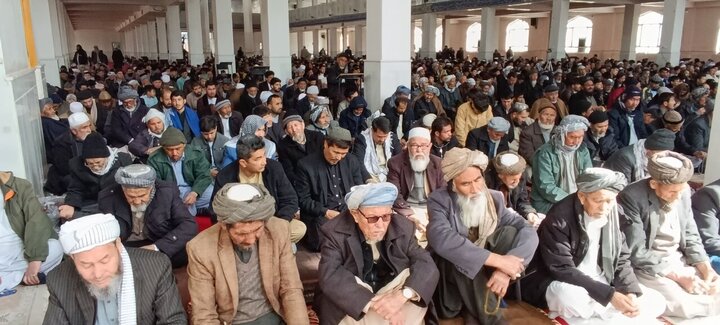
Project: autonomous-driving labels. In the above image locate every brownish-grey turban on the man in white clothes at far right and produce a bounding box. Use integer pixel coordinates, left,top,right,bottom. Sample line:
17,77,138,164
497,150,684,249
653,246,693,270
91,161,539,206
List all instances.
647,151,693,184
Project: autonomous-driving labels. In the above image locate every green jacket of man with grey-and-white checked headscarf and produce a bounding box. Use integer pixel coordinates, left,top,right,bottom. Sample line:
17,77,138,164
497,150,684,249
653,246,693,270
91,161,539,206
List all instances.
530,141,592,213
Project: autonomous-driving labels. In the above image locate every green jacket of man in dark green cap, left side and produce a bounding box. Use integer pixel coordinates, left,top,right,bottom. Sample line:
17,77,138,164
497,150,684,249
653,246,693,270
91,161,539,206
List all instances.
148,146,212,196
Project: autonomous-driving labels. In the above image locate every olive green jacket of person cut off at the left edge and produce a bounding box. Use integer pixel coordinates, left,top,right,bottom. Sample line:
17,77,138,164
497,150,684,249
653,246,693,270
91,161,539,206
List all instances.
0,174,57,262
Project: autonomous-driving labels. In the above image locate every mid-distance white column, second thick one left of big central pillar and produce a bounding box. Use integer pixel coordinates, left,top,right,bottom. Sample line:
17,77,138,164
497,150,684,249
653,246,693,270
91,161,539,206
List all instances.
213,0,236,73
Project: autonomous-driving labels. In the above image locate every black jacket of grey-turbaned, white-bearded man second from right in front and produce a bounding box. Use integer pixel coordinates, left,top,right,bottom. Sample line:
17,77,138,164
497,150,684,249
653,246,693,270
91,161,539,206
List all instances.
522,194,642,307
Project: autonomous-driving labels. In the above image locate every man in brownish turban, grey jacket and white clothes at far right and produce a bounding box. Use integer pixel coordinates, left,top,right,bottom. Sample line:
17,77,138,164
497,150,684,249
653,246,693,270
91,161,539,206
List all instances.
618,151,720,318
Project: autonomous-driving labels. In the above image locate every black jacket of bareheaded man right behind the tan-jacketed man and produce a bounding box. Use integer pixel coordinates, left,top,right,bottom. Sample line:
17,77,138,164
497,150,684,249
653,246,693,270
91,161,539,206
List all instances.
212,159,298,221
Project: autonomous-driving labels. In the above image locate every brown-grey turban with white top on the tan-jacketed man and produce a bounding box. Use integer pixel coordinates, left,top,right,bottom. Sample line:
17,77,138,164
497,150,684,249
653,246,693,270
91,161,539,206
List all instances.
212,183,275,224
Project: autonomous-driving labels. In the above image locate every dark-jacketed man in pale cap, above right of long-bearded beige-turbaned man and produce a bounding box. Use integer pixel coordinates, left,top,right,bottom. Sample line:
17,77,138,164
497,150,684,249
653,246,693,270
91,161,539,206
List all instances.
465,116,510,159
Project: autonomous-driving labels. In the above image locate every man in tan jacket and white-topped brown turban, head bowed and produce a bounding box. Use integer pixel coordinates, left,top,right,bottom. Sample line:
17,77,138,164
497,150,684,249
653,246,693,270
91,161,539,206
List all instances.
187,183,309,325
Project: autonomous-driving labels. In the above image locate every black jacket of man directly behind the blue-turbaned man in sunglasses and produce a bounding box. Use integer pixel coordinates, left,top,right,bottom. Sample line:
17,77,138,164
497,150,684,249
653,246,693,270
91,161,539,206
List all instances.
295,152,365,252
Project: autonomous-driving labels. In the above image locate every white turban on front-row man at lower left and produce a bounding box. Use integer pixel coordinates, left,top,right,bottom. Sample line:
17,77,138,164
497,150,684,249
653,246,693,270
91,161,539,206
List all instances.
58,213,120,255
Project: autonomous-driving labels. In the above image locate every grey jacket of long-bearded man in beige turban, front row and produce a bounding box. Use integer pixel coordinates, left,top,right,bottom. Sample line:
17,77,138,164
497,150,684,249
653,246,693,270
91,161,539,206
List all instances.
427,188,538,279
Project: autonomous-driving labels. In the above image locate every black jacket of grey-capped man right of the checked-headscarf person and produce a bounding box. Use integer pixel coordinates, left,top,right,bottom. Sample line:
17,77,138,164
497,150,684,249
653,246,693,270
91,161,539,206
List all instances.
277,129,325,184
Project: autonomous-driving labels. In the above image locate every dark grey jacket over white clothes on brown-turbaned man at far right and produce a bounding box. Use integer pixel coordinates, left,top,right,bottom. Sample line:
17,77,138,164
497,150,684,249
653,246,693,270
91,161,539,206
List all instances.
618,179,708,276
